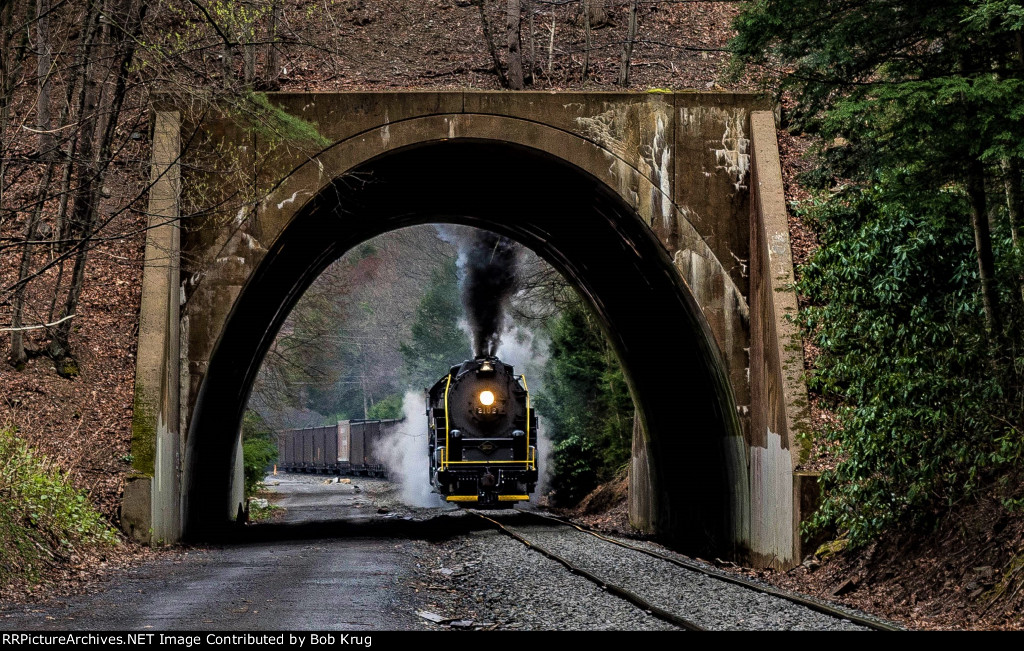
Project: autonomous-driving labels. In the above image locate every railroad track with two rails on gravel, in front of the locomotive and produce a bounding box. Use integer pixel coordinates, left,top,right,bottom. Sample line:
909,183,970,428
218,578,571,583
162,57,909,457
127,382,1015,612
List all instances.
470,510,900,631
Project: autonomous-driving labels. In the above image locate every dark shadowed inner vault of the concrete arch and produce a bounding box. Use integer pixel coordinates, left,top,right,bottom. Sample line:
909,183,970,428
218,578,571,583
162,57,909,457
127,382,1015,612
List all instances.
182,139,745,554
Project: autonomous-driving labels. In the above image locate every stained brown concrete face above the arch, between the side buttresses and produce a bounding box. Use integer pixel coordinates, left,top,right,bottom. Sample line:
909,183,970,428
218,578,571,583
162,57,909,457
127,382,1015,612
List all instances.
185,92,767,452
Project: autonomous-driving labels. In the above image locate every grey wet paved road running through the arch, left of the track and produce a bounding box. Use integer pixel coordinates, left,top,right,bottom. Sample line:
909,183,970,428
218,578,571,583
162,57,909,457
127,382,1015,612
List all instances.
0,475,440,631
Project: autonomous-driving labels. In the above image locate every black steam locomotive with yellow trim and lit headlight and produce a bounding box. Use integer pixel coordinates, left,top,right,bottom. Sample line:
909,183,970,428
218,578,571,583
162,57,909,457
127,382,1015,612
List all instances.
427,356,538,509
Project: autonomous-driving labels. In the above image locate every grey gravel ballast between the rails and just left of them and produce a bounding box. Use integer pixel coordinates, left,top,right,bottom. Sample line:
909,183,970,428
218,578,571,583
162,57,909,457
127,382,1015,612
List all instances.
428,511,876,631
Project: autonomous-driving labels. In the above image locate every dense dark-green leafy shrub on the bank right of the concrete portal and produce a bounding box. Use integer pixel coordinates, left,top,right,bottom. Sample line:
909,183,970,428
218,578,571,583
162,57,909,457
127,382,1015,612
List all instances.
800,180,1024,546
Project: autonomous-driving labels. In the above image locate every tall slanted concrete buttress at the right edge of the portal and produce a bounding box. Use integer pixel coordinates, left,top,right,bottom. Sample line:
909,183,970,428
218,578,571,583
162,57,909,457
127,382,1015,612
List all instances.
750,112,808,566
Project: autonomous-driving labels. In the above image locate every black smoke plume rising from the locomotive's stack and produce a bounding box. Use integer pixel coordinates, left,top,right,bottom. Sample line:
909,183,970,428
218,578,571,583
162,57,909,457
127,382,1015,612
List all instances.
461,230,518,356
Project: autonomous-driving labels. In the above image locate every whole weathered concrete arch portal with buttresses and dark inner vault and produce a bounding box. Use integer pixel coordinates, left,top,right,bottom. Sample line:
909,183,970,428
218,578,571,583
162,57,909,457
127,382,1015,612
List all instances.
128,92,802,564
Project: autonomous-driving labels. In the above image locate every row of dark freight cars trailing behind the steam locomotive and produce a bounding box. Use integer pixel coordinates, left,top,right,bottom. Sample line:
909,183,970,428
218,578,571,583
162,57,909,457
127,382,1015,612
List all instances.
278,420,400,477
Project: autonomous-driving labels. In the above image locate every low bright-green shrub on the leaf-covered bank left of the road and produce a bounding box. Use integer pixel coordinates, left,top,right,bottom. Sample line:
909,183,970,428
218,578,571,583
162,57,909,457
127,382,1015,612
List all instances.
0,430,118,585
